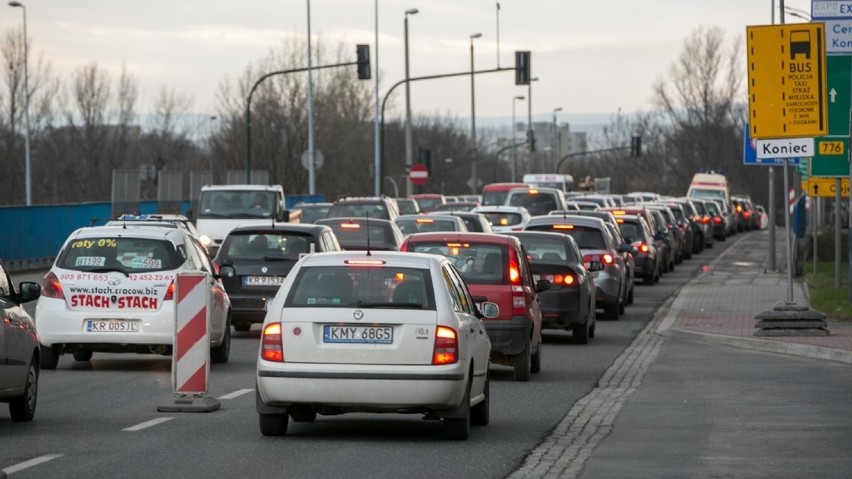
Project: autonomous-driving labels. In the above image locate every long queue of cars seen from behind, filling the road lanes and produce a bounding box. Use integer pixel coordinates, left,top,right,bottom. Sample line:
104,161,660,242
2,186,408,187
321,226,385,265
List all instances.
0,186,736,432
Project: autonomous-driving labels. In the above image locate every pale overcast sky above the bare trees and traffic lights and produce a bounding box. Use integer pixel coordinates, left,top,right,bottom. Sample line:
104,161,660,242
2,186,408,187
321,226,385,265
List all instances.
0,0,810,124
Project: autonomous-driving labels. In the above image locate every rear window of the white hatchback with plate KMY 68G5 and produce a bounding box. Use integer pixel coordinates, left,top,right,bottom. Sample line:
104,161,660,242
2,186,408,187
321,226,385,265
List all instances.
285,266,435,310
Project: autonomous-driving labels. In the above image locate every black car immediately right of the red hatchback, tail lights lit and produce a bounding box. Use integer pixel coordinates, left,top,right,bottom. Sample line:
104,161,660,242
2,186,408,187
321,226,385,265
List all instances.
505,231,596,344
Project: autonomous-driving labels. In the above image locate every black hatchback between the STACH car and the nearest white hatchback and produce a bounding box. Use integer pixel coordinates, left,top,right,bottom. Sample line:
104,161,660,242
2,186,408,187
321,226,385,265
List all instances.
213,223,341,331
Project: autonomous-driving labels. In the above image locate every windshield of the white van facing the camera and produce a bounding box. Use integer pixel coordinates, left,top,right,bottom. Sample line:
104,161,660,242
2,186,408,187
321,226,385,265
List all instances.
198,190,276,218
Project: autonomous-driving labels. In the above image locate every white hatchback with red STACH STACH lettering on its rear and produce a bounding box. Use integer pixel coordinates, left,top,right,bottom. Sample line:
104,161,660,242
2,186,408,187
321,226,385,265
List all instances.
35,226,231,369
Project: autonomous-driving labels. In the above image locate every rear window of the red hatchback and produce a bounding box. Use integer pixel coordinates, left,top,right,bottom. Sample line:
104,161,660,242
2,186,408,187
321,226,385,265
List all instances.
408,241,508,284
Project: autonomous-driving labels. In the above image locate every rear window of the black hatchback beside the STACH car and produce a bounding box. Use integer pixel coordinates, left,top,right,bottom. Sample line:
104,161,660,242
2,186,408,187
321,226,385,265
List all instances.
219,231,316,263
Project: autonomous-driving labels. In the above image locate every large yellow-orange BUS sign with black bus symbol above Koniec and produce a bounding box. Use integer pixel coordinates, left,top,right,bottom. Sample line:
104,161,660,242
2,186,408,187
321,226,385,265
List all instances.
746,23,828,139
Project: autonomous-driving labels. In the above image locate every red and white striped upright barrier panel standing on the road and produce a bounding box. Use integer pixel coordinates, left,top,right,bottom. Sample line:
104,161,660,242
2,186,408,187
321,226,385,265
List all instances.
157,272,219,412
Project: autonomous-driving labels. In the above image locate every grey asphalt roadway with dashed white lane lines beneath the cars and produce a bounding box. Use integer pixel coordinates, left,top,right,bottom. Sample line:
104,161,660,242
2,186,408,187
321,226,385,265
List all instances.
0,248,730,479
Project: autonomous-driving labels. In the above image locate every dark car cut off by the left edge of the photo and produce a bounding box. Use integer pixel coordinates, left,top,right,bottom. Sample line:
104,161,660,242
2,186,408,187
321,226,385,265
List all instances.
0,264,41,422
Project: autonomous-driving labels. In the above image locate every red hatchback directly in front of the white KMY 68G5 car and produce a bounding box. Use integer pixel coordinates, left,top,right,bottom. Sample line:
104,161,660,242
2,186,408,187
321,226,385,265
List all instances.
400,232,550,381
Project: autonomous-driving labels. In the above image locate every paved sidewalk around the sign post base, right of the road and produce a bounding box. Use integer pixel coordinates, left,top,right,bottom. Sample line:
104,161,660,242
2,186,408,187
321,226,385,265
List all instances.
657,228,852,364
